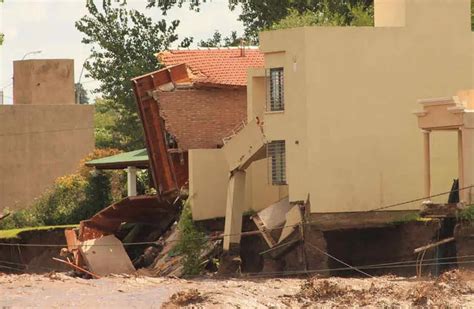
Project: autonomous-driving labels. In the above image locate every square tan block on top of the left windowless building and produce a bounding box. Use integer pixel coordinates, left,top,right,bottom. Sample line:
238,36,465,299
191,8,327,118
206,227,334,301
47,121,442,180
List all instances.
13,59,75,105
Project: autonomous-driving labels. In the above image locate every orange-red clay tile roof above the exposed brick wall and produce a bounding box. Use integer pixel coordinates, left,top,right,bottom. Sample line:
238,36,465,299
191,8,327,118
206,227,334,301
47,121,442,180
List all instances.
156,47,264,87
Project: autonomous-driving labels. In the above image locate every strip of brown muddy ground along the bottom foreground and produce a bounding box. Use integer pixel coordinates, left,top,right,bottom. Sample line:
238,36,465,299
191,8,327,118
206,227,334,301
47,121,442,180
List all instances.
0,271,474,308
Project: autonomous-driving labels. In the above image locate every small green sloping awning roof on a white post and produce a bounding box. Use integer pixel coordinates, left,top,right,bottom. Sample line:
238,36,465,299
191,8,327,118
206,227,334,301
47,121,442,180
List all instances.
86,149,148,170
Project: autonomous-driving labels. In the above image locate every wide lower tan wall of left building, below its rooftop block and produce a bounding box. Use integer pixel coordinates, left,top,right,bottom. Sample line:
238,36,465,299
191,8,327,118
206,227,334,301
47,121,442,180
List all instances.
0,105,94,213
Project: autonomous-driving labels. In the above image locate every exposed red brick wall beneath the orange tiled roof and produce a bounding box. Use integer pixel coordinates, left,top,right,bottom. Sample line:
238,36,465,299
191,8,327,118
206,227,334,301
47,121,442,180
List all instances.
158,88,247,150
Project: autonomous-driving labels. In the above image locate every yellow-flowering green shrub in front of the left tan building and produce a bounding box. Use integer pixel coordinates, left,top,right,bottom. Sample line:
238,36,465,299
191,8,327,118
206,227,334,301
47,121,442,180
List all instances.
0,149,125,229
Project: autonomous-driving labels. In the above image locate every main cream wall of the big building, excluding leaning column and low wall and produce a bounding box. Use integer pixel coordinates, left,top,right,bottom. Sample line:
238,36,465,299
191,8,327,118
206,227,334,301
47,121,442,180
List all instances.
260,0,473,212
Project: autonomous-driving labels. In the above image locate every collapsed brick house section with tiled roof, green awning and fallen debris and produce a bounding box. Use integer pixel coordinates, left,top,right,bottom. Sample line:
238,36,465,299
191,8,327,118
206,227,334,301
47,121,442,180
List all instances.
57,47,263,276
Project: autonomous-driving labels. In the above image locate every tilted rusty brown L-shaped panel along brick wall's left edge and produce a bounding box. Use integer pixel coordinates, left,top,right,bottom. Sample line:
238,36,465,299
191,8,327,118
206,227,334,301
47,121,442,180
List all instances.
132,64,189,196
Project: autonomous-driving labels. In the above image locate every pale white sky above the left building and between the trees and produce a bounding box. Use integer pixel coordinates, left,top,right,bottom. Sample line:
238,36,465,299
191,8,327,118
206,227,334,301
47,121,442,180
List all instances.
0,0,243,104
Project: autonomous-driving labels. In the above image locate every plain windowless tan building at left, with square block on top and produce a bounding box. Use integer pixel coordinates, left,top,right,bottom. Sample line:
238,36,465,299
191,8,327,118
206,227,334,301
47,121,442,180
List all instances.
0,59,94,213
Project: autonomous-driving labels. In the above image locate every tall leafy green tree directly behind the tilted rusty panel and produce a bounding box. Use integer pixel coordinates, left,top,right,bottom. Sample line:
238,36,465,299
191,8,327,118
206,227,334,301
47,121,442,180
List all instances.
76,0,183,150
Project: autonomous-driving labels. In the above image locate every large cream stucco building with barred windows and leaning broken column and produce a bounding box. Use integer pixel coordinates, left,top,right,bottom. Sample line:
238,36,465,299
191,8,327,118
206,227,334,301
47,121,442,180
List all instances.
189,0,474,248
